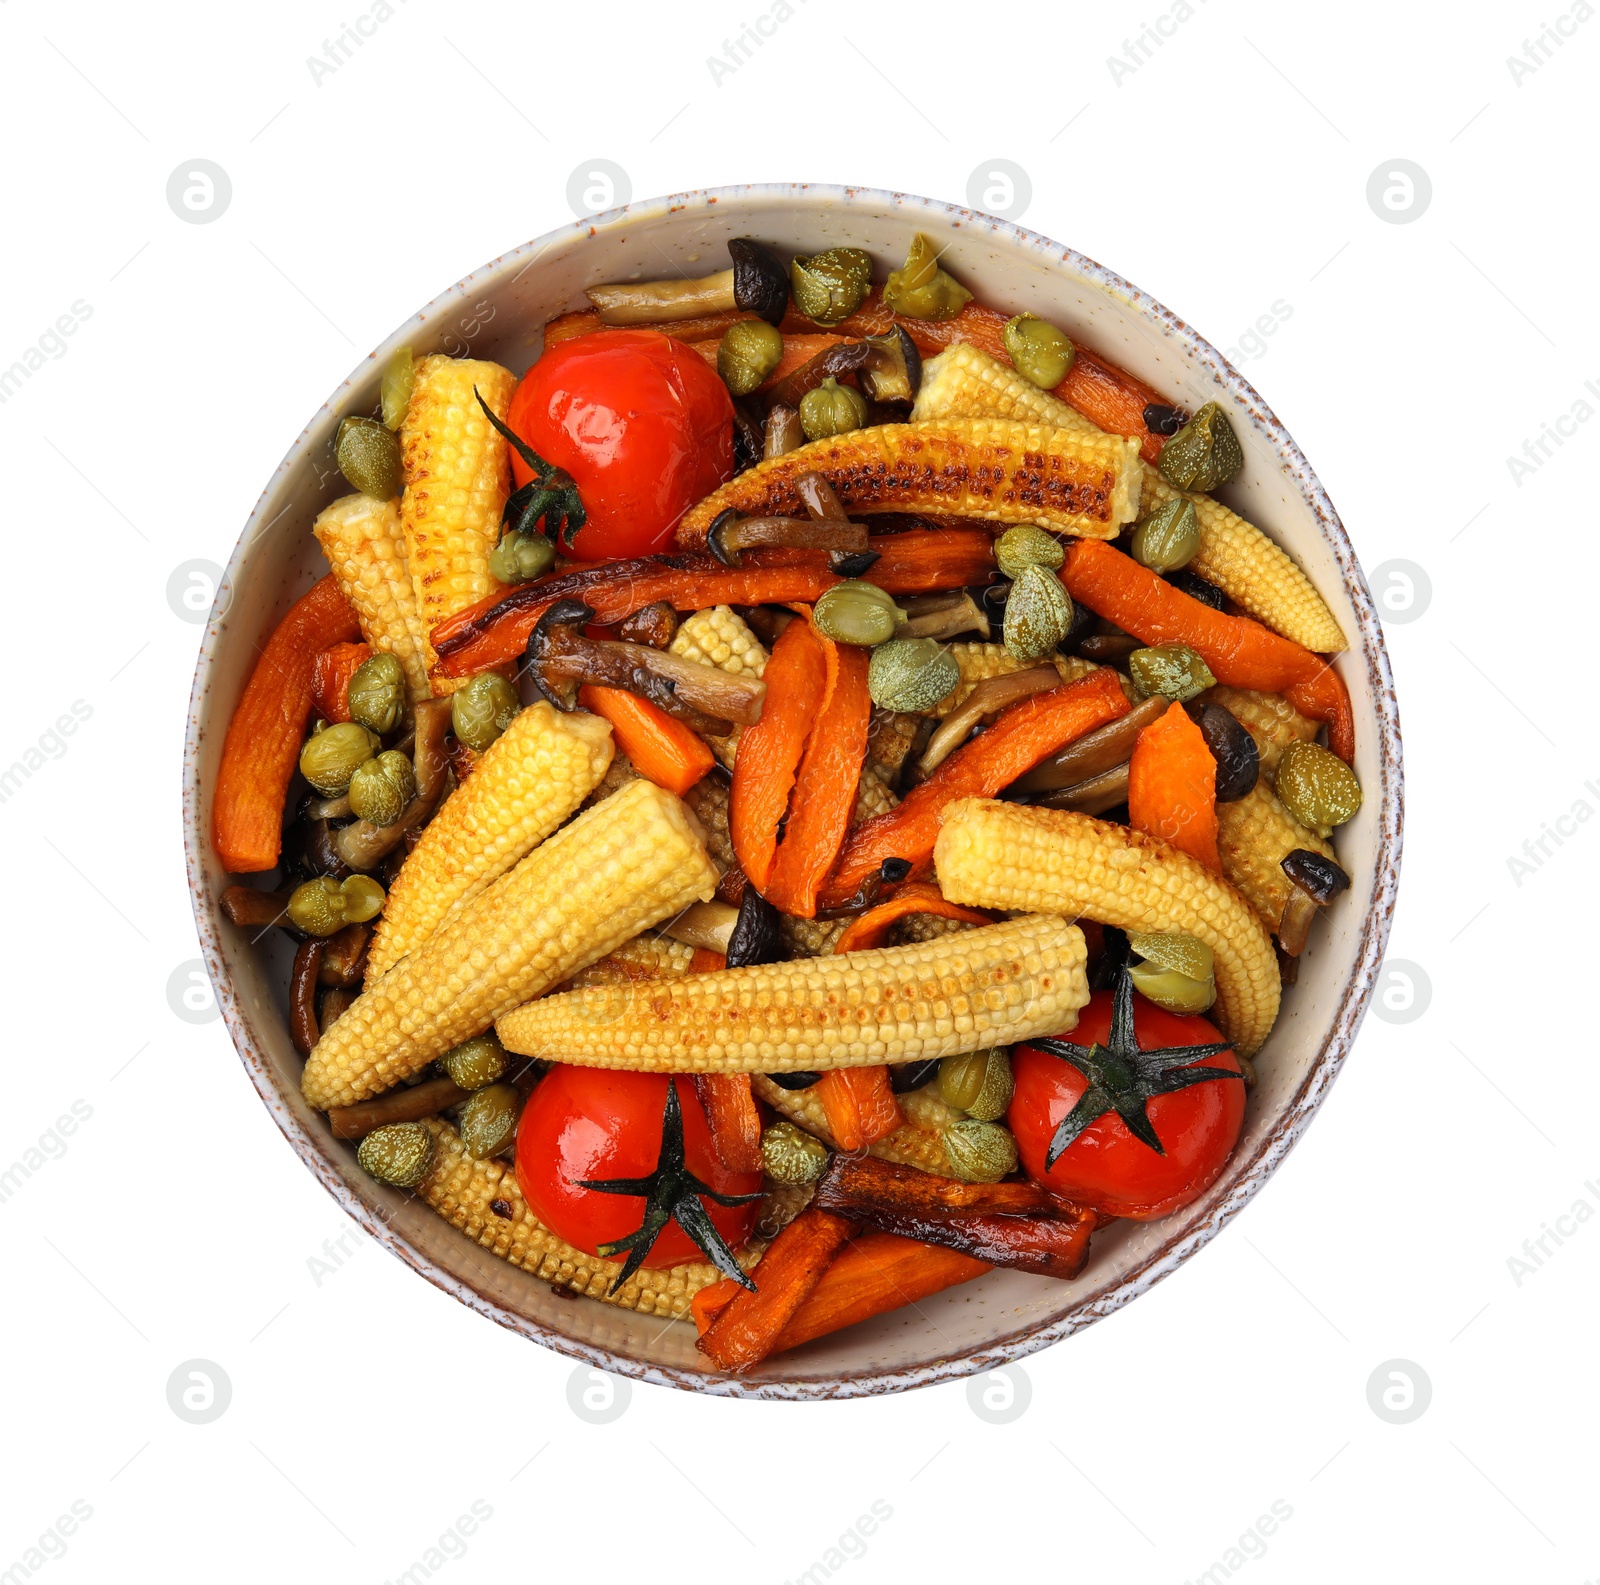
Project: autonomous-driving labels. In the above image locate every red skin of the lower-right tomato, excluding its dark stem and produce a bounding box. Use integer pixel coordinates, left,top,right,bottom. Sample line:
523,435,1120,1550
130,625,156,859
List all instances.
1008,990,1245,1220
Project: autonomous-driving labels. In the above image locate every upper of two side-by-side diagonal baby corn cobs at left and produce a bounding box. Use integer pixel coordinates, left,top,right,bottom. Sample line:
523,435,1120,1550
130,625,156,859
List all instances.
366,699,611,980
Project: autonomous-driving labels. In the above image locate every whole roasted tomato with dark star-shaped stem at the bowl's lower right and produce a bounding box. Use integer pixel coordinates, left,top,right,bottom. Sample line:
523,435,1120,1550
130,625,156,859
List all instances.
1008,979,1245,1220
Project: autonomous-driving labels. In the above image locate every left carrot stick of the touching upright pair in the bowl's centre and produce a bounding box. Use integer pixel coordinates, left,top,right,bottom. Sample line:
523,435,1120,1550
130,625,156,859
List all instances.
728,622,827,897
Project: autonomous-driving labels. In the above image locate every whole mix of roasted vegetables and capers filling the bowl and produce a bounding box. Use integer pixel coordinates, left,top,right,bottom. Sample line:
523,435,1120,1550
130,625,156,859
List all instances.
210,234,1362,1372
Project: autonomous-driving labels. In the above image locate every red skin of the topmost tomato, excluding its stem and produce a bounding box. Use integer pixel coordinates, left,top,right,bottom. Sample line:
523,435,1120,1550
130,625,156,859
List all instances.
506,329,733,561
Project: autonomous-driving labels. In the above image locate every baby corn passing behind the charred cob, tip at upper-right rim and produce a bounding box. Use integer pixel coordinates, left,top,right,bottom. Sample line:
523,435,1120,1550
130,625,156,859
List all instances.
912,342,1347,654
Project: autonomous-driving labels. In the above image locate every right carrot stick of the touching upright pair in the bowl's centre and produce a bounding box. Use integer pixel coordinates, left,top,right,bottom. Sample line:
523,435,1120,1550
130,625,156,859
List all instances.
764,622,872,920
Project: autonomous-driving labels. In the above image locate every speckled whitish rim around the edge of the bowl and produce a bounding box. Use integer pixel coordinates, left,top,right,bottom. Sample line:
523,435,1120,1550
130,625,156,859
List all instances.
184,182,1405,1401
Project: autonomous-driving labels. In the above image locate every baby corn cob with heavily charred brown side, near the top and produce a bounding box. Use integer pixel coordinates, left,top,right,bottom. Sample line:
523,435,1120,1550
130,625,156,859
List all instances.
678,417,1144,545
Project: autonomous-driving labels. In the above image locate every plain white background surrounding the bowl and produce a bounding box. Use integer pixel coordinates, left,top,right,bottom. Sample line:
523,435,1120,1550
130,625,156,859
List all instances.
0,0,1600,1585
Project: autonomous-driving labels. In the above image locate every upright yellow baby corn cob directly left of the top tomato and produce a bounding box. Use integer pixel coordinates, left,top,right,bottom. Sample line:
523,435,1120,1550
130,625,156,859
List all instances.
400,353,517,693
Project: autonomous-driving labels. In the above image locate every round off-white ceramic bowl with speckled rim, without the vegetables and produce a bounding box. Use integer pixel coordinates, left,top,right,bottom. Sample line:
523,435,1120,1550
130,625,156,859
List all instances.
184,184,1402,1398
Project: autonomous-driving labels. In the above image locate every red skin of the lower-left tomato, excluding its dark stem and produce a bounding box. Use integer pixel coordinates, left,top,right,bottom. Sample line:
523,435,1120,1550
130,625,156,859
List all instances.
517,1064,762,1267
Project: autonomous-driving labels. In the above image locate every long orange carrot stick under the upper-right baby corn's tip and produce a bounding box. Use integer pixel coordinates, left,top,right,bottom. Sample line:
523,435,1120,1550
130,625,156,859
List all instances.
1061,539,1355,761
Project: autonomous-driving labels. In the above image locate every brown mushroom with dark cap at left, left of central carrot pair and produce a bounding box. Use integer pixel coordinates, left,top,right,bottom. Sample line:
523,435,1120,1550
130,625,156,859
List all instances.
528,600,766,737
